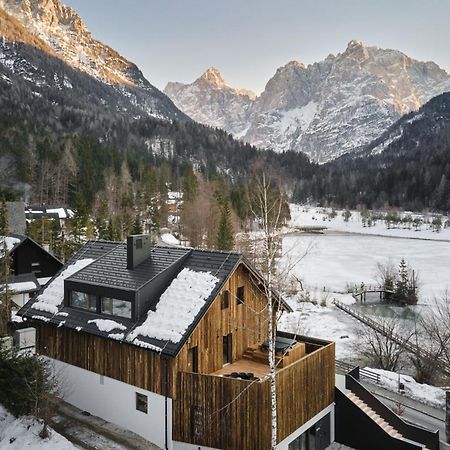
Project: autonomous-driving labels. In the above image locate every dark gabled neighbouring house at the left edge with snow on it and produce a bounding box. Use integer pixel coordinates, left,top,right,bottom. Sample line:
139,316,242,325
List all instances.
0,234,63,307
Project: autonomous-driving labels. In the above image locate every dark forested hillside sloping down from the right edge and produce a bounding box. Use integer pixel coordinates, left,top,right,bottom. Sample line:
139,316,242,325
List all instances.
294,93,450,212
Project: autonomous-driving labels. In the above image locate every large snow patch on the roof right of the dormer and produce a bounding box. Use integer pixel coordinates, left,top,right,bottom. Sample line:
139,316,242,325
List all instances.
127,268,219,343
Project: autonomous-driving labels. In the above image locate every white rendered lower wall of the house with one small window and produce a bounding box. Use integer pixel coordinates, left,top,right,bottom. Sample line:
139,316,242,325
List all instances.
51,359,173,449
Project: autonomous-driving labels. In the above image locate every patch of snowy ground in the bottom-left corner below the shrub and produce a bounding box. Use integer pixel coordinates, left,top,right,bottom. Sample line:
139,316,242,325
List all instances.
0,405,76,450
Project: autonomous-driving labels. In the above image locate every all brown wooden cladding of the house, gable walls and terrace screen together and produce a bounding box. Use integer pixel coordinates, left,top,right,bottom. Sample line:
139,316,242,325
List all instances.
36,264,335,450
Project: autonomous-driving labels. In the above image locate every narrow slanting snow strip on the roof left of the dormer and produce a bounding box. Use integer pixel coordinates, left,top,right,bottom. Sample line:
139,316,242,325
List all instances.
31,258,94,314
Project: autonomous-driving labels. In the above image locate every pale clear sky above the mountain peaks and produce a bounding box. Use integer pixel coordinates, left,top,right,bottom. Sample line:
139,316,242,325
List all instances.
63,0,450,93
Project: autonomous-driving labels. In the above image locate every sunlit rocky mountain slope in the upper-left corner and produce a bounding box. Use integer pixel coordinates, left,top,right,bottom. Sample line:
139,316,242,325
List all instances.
0,0,184,119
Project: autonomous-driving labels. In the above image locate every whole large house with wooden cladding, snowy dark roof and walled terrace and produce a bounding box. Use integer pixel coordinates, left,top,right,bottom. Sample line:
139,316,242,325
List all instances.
18,236,335,450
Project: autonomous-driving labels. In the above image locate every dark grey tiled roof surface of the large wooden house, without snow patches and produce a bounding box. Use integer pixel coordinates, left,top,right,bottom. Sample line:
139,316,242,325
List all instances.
18,241,288,356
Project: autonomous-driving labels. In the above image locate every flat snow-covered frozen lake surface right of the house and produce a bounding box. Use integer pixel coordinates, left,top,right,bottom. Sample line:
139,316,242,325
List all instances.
282,231,450,303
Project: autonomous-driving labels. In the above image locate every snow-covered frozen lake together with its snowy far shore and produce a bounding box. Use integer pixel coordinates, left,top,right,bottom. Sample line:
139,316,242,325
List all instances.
281,205,450,303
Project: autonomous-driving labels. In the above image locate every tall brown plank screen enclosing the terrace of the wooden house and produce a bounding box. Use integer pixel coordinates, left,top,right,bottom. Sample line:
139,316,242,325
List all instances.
173,343,335,450
